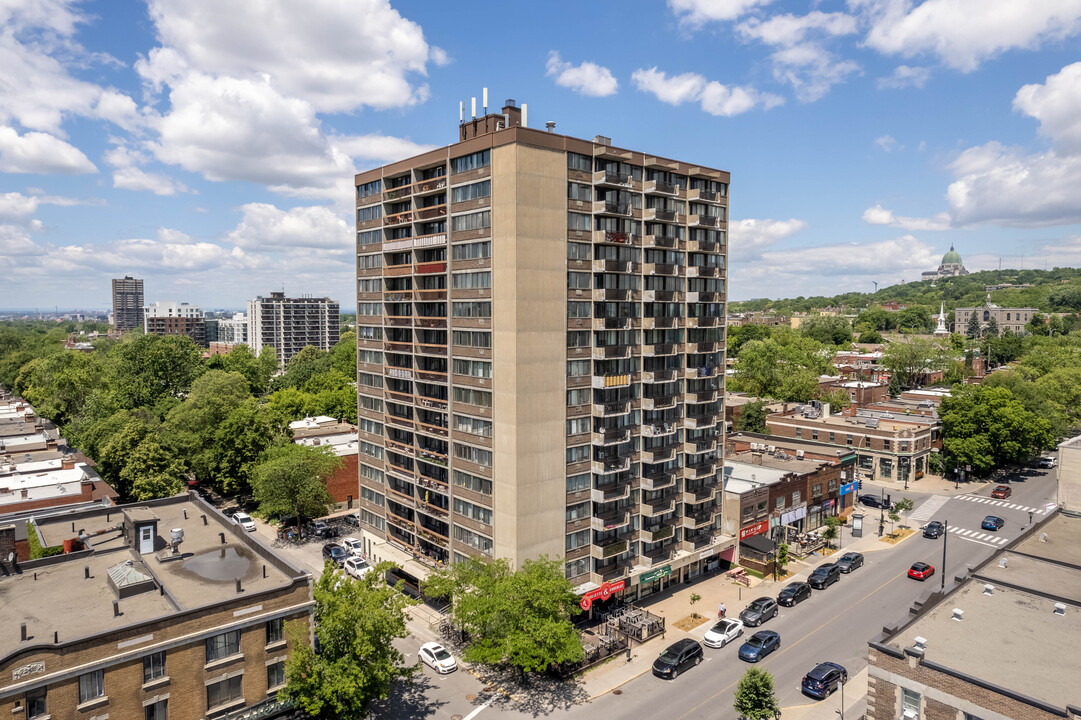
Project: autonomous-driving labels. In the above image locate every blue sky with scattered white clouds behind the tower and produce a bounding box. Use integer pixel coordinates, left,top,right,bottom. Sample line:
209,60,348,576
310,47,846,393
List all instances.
0,0,1081,308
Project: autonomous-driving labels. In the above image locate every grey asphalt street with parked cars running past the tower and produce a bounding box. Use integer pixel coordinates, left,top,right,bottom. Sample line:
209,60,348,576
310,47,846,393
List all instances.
374,470,1054,720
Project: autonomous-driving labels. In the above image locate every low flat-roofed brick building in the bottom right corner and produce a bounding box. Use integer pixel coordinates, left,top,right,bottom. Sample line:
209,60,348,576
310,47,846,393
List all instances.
867,515,1081,720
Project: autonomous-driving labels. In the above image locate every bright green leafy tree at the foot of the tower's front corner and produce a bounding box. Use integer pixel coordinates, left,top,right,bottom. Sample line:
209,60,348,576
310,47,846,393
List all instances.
424,557,584,672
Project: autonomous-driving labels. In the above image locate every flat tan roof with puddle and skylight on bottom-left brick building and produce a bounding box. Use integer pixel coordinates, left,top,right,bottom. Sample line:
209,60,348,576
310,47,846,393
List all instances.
0,496,307,657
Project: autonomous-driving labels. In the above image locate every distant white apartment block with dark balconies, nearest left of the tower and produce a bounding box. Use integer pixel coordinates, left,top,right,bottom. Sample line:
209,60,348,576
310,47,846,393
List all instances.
246,292,339,365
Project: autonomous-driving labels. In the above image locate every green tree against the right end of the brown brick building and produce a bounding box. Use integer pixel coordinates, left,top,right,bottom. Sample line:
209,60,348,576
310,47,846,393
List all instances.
278,564,417,720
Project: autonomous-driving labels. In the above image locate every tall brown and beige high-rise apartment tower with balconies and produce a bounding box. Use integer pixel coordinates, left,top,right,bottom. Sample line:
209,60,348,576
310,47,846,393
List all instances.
356,101,735,597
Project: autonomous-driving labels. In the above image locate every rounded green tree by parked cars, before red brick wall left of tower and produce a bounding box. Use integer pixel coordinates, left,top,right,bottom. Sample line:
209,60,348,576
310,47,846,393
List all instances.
252,442,342,518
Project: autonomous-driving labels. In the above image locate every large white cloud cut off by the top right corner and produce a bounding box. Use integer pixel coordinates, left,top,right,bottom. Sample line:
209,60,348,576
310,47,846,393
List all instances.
849,0,1081,72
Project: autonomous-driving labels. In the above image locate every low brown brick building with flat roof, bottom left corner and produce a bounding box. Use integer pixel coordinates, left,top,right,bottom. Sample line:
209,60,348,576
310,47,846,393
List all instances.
0,495,312,720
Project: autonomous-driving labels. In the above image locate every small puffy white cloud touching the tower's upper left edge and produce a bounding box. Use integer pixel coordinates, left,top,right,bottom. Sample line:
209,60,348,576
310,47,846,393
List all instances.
228,202,353,251
